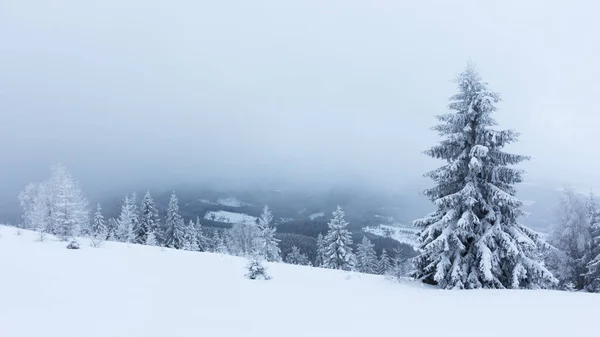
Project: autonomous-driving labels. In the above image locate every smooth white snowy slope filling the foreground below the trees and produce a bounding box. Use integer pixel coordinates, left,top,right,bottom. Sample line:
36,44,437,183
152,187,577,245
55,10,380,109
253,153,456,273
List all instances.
0,226,600,337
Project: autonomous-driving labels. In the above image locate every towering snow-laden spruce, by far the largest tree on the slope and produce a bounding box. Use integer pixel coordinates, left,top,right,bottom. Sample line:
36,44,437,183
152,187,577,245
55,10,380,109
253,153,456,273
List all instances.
412,66,556,289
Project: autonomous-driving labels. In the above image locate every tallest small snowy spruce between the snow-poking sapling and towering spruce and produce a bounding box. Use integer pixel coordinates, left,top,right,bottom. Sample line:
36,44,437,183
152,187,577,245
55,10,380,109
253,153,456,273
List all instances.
323,206,356,271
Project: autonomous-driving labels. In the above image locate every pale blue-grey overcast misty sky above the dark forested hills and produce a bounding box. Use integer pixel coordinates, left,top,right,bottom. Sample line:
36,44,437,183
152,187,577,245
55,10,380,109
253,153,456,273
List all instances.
0,0,600,198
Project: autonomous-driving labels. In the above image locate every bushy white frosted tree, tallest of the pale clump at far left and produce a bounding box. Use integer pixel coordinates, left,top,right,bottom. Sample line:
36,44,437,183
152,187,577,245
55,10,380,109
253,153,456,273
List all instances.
47,164,89,241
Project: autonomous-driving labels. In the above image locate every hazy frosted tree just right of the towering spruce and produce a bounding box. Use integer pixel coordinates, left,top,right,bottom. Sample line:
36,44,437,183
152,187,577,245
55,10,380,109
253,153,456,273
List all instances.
546,188,592,290
